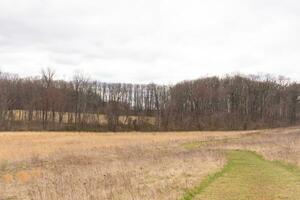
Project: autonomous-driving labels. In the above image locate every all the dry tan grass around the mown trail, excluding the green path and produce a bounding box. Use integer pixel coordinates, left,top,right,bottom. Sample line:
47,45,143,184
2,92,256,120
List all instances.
0,128,300,200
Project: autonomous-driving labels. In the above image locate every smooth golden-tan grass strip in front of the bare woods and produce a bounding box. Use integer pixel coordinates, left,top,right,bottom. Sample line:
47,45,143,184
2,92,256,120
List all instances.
0,131,251,162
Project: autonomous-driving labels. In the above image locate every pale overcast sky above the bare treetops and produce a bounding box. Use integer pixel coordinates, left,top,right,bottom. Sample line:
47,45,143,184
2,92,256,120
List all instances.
0,0,300,83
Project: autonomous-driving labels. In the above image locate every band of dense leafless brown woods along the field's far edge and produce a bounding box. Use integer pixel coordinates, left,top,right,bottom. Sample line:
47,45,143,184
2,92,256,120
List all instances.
0,69,300,131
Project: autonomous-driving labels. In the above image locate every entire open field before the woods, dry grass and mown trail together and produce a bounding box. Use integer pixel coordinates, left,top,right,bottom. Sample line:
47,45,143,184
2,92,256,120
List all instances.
0,127,300,200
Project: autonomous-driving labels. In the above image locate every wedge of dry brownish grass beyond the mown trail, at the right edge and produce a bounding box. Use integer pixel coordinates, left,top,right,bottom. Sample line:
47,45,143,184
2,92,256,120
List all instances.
192,127,300,166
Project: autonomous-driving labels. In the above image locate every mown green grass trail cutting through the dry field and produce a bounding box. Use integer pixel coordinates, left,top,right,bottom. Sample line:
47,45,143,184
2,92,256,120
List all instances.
182,151,300,200
